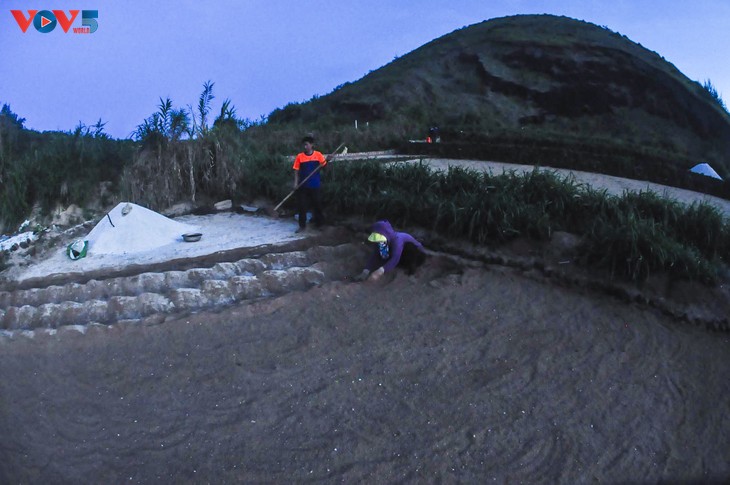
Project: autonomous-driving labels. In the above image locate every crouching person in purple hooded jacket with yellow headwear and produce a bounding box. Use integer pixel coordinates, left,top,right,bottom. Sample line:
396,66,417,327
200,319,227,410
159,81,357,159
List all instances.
355,221,426,281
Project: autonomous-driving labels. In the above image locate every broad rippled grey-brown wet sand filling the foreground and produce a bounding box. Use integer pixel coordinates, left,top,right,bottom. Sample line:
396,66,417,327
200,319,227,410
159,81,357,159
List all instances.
0,258,730,483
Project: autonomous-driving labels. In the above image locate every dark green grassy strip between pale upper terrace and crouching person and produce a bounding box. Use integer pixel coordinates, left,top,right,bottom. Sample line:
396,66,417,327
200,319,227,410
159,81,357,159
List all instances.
325,162,730,283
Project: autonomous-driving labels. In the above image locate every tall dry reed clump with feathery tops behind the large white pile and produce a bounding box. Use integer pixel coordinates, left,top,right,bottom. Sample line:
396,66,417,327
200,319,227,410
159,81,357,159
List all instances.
121,81,300,210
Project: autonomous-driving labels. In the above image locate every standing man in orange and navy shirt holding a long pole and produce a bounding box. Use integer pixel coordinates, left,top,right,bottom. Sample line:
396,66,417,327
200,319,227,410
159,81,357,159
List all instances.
293,135,327,232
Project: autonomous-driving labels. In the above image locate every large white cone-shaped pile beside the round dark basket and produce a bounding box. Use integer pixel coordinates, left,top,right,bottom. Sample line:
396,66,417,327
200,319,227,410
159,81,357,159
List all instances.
86,202,200,255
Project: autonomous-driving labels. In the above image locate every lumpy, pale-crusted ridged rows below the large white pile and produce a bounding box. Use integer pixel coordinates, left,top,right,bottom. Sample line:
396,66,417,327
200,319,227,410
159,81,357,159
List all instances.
0,245,362,331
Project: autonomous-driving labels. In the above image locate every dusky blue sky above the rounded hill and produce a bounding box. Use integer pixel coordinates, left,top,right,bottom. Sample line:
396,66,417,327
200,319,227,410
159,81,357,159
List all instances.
0,0,730,138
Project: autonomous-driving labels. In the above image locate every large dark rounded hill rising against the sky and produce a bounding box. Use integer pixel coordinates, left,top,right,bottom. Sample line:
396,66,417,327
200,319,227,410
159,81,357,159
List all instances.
269,15,730,191
